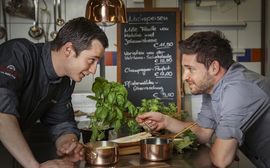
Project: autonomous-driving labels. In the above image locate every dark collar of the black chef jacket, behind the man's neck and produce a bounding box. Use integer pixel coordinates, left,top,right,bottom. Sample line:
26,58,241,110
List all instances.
42,43,62,83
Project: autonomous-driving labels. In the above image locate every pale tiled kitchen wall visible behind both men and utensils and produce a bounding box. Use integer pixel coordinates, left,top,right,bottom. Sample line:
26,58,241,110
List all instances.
0,0,261,92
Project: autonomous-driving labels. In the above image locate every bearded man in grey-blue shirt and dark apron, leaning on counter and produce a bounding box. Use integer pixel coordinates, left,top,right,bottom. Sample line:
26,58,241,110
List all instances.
137,31,270,168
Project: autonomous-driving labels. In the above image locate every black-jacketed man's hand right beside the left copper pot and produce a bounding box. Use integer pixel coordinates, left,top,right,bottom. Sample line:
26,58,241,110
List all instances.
56,134,85,162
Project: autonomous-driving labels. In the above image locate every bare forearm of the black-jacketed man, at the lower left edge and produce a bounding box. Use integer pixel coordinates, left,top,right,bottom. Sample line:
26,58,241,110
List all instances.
0,112,39,168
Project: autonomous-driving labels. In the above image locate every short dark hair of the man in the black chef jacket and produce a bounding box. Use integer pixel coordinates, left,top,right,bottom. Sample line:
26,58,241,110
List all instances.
51,17,109,54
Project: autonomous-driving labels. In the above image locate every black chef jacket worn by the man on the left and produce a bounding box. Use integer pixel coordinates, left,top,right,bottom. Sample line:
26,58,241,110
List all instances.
0,39,79,140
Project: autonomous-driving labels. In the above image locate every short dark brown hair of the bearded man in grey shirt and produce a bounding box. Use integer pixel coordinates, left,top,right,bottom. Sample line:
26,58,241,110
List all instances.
179,30,234,69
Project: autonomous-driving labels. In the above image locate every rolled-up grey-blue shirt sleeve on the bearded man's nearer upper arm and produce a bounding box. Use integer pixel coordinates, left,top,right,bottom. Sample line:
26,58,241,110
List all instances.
215,82,265,145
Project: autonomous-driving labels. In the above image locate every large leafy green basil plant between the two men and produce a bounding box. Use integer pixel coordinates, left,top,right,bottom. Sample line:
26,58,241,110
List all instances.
87,77,137,140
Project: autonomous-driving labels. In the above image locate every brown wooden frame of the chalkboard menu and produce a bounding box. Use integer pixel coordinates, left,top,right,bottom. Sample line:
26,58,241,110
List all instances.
117,8,182,113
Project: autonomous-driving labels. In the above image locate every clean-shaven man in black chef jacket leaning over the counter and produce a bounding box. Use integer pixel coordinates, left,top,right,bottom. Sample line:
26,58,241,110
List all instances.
0,17,108,168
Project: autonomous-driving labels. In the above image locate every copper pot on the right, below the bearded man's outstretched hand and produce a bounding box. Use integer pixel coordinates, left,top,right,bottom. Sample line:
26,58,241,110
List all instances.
140,138,173,161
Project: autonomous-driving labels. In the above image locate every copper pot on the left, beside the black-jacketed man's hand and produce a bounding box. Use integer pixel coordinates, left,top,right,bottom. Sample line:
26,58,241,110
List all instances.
85,141,119,166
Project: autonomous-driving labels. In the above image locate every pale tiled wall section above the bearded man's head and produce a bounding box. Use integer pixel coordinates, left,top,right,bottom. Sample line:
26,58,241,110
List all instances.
184,0,261,49
